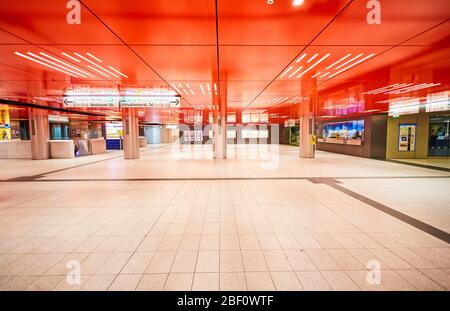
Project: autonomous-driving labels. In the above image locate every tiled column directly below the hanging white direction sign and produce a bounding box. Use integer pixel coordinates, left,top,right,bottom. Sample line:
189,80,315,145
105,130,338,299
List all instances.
122,108,140,160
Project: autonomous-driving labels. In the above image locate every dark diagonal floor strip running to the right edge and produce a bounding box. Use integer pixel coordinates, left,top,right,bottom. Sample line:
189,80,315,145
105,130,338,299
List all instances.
326,183,450,244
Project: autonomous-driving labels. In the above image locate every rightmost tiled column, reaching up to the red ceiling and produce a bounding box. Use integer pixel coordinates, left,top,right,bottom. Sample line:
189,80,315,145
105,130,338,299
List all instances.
299,79,317,158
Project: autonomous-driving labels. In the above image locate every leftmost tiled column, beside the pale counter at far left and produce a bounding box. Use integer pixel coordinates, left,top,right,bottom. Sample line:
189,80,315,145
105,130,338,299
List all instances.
28,108,50,160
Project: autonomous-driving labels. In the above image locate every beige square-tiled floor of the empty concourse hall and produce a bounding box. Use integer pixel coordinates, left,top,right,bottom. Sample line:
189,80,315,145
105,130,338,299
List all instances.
0,146,450,291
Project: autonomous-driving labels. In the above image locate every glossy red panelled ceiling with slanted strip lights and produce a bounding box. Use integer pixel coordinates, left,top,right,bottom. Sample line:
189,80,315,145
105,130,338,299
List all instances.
0,0,450,122
